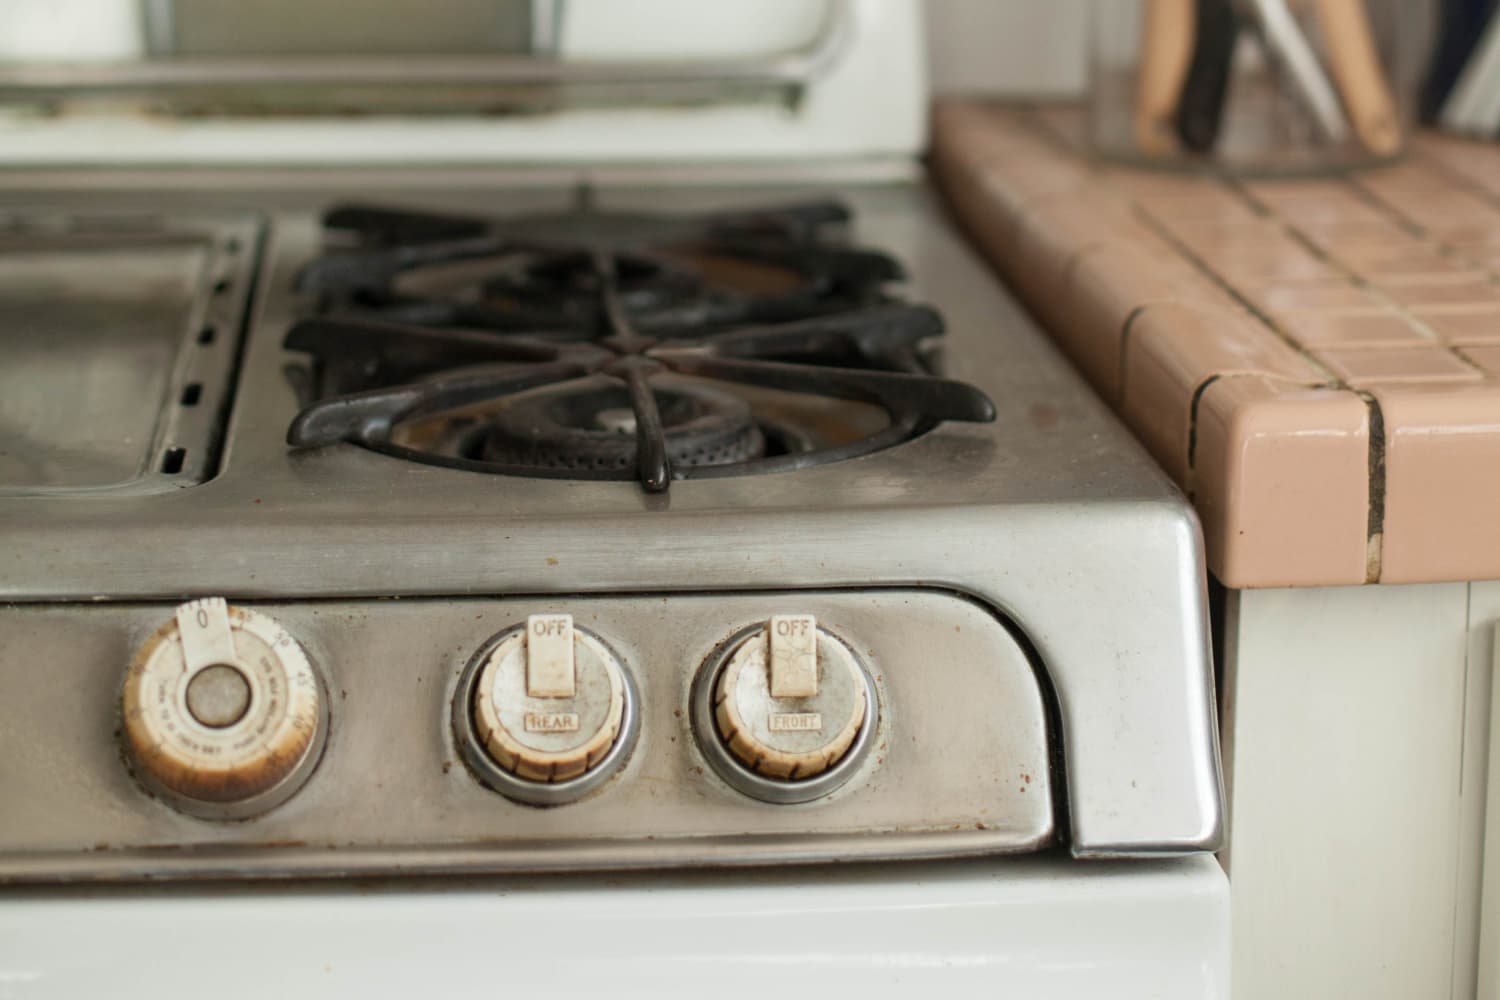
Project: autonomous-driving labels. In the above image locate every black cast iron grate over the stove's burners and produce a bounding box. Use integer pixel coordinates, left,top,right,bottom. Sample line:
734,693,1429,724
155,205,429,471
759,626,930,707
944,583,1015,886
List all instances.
285,190,995,493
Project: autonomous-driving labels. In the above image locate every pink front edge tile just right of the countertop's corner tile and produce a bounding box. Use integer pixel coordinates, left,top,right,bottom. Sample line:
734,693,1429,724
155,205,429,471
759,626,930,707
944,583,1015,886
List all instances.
1371,382,1500,583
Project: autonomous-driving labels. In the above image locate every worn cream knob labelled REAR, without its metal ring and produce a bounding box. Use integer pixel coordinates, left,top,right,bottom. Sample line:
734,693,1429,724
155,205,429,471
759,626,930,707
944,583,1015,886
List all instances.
473,615,627,790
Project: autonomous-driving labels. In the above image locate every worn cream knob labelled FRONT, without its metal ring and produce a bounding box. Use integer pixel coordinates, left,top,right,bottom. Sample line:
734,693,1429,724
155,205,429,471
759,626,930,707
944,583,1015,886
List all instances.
713,615,869,780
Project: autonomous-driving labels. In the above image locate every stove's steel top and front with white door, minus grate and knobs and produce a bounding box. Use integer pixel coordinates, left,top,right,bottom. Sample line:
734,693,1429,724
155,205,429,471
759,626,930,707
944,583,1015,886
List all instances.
0,4,1227,996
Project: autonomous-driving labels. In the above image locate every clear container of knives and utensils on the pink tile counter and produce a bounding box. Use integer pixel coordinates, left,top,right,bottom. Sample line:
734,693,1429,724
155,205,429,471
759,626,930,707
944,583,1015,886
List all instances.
1088,0,1428,175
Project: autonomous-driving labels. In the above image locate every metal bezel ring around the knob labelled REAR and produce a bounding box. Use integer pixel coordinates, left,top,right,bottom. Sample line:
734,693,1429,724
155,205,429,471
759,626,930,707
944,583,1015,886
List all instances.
452,625,641,805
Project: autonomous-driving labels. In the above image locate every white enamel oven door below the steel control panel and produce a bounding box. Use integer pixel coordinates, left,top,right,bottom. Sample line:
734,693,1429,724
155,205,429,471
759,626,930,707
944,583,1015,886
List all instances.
0,855,1229,1000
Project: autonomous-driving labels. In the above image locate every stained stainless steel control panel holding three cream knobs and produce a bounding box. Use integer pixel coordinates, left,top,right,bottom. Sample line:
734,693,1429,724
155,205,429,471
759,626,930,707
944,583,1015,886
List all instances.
0,589,1055,882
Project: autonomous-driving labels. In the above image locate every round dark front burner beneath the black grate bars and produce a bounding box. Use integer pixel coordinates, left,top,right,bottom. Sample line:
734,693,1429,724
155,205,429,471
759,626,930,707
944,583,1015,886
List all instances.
479,382,767,469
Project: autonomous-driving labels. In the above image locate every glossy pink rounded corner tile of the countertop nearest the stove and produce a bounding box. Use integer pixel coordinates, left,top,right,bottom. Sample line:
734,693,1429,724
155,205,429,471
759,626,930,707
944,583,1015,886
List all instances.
1191,376,1371,588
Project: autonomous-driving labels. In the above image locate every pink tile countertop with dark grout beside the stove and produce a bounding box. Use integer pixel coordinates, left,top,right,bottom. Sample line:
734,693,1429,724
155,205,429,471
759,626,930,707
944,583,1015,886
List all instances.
932,100,1500,588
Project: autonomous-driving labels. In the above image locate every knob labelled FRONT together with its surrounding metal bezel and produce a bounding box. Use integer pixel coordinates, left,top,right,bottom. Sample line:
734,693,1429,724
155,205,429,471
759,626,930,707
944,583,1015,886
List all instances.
695,615,879,802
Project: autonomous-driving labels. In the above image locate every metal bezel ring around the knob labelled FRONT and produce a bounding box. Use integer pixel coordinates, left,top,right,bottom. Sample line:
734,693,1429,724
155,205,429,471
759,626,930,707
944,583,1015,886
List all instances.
689,622,881,805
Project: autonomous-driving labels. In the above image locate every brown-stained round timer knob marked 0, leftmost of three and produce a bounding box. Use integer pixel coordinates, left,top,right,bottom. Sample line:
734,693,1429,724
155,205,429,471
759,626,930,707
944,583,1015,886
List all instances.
122,597,329,819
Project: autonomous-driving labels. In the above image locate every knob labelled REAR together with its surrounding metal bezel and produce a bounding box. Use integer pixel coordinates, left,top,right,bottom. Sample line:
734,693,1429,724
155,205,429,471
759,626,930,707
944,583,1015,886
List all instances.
455,613,638,805
